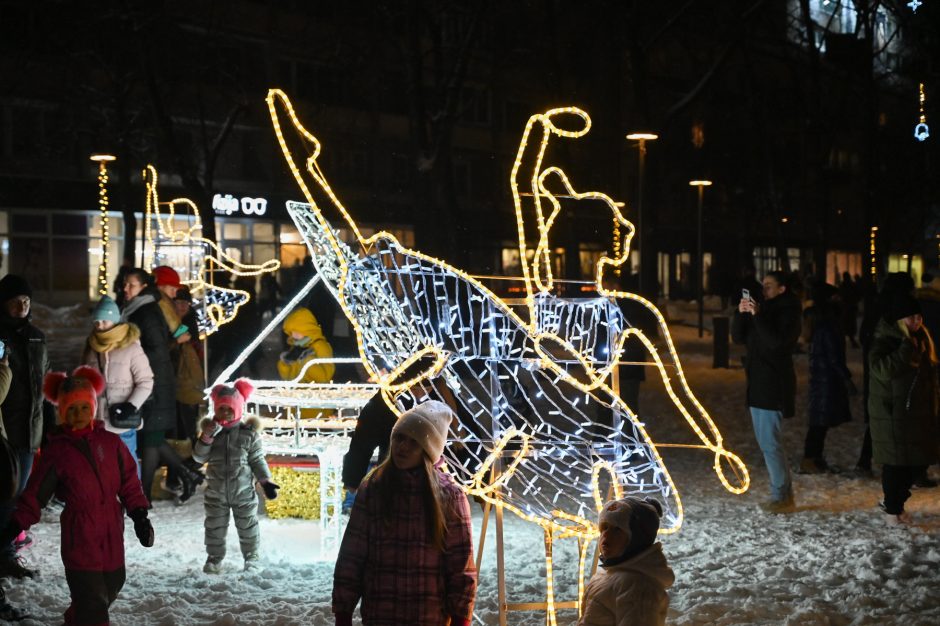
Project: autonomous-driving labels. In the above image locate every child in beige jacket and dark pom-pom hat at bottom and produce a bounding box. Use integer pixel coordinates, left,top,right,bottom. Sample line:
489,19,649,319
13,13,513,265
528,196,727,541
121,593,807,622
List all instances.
578,497,675,626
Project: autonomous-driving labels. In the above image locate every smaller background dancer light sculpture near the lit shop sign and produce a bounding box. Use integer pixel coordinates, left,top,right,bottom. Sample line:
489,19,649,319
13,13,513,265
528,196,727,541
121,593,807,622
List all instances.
143,165,281,339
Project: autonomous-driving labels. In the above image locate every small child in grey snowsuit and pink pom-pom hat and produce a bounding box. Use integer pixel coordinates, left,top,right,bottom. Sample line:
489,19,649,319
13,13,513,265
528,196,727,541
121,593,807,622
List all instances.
193,378,279,574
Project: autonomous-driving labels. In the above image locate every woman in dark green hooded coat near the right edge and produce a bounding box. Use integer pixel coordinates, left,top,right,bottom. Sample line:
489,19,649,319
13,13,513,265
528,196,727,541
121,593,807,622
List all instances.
868,294,940,523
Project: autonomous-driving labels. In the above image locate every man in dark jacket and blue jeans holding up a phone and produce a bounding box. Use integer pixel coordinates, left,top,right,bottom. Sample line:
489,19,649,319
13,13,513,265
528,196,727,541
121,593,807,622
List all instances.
731,272,801,513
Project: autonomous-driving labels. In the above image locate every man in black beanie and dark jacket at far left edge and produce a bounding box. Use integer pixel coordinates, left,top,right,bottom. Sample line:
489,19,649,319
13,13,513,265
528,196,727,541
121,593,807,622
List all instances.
0,274,49,578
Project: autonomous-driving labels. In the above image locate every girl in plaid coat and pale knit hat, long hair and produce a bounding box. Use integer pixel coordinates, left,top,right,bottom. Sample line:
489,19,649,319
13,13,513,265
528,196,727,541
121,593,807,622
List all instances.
333,400,477,626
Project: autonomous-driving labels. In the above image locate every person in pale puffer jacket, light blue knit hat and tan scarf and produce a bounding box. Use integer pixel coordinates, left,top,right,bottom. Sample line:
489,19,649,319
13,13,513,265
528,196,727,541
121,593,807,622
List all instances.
82,296,153,466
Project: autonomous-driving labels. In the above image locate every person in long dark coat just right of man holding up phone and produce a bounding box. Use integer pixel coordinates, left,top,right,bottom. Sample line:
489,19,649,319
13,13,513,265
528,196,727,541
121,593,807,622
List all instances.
800,283,853,474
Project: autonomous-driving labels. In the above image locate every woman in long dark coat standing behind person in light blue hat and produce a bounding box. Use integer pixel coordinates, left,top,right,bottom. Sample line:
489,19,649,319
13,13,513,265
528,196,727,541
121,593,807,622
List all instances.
121,268,199,501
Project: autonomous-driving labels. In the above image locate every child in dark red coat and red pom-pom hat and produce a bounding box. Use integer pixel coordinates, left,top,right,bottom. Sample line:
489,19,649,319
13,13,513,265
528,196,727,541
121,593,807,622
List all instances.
2,365,153,625
